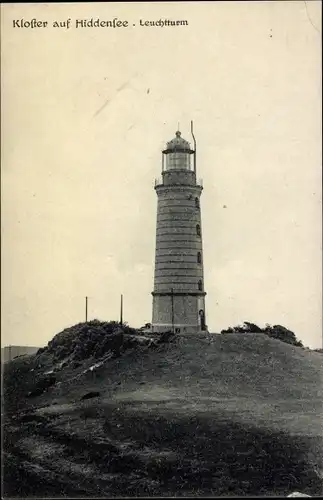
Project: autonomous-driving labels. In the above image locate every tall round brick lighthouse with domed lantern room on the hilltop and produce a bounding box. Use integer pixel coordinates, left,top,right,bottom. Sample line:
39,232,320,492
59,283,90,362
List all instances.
152,123,207,334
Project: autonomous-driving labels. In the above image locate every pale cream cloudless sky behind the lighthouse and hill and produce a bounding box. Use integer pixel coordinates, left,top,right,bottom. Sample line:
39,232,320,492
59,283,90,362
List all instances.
1,1,322,347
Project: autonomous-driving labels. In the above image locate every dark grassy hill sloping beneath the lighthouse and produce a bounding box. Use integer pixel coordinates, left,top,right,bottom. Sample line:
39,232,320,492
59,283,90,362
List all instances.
4,322,323,496
